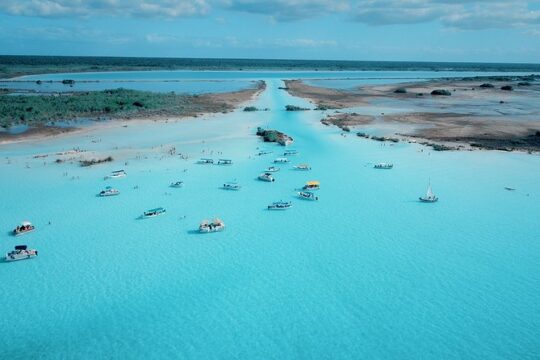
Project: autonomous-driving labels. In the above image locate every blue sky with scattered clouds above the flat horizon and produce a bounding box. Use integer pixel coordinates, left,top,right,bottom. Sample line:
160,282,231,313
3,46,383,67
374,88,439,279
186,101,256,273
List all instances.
0,0,540,63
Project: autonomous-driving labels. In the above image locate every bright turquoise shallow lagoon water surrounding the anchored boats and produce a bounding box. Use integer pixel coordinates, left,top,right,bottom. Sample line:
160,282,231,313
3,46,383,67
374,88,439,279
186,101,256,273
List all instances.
0,79,540,359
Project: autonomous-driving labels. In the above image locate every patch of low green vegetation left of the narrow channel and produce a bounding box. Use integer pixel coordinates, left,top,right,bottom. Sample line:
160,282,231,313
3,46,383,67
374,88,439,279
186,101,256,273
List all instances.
0,89,232,128
